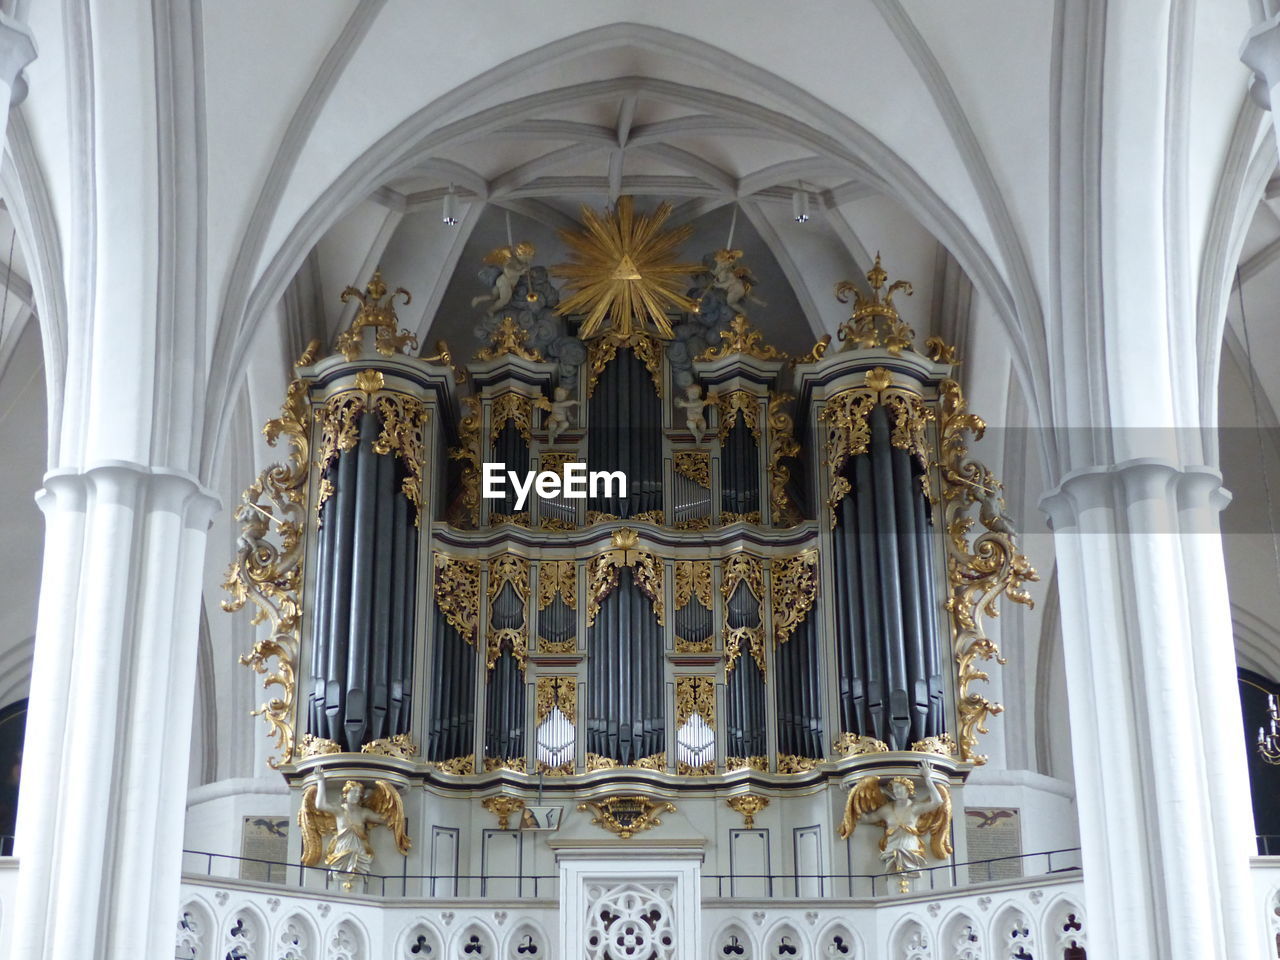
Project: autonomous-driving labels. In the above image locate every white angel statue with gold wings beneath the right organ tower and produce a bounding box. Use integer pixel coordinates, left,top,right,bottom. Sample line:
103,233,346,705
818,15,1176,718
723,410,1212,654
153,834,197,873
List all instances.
840,758,951,890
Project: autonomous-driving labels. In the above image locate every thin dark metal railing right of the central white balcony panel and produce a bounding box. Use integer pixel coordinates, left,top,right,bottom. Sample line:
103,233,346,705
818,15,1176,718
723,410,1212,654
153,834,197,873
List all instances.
703,846,1080,900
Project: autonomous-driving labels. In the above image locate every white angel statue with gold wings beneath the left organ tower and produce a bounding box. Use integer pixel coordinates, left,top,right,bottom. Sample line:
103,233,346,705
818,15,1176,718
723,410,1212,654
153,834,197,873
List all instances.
298,774,410,890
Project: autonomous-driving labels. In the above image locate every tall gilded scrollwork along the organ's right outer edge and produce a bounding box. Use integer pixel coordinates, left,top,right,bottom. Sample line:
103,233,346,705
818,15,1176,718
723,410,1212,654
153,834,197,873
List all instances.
940,380,1039,763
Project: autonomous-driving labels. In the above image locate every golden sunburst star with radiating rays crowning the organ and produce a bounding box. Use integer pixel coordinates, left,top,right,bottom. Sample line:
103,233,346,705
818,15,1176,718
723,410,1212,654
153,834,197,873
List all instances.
553,197,701,340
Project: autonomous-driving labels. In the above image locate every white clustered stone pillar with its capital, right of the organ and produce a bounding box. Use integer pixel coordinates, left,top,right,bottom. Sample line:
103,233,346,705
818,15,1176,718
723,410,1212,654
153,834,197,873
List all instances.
1043,460,1261,960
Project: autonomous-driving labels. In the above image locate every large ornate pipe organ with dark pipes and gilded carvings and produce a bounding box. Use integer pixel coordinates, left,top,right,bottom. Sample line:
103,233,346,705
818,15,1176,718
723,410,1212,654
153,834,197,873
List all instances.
227,198,1036,901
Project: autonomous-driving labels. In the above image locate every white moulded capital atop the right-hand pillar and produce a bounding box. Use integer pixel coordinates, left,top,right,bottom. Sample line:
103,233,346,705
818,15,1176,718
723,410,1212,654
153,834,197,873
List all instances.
1039,457,1231,534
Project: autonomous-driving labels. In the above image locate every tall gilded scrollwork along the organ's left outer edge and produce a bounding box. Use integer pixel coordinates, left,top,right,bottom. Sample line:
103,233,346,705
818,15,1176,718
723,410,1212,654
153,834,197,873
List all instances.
223,380,311,767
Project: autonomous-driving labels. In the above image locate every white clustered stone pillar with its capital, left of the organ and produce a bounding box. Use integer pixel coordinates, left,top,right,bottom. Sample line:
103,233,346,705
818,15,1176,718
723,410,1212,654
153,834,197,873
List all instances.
12,462,218,960
